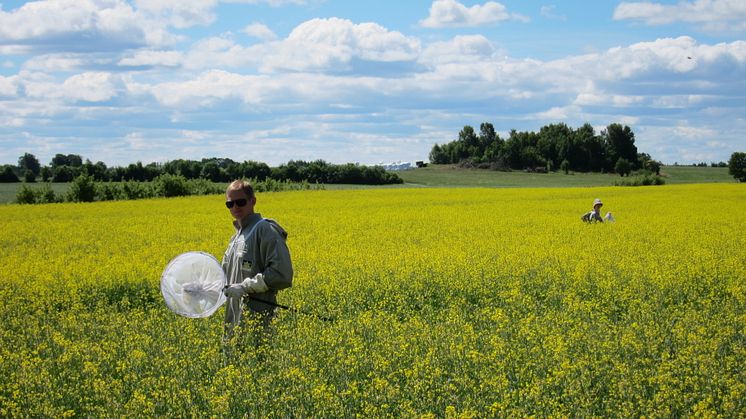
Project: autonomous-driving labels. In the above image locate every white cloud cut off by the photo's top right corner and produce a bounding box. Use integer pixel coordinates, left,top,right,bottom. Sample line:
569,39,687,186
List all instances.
614,0,746,31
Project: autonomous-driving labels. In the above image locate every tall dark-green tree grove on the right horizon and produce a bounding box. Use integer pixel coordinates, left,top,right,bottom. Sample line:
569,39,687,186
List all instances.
430,122,662,175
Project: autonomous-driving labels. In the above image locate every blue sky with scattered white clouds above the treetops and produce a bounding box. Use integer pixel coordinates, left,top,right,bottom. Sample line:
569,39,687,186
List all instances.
0,0,746,165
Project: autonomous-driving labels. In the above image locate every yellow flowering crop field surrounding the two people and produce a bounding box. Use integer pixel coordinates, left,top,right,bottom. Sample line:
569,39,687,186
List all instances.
0,184,746,417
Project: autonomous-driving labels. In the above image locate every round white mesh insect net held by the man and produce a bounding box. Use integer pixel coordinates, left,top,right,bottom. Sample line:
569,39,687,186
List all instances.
161,252,226,317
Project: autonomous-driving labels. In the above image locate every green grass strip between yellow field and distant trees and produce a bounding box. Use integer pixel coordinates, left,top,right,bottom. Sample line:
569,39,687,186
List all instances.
0,165,735,204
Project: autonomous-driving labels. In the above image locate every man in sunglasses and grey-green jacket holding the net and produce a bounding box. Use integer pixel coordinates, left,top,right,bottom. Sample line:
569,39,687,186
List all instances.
222,180,293,346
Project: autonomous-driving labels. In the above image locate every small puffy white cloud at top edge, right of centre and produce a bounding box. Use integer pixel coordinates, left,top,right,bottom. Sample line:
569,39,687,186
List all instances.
420,0,529,28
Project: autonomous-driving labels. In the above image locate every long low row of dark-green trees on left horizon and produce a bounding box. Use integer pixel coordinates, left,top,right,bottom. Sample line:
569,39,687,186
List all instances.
0,153,403,185
